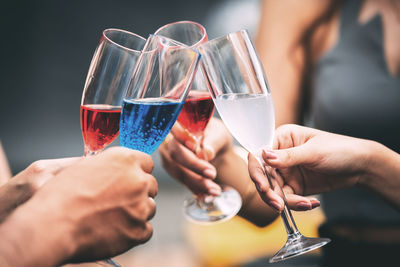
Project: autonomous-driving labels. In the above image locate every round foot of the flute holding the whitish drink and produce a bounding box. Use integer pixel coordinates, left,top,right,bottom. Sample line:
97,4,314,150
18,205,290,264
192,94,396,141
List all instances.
269,232,331,263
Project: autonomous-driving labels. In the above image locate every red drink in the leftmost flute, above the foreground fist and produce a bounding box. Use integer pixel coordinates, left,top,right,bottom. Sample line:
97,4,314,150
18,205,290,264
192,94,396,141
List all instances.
81,105,121,154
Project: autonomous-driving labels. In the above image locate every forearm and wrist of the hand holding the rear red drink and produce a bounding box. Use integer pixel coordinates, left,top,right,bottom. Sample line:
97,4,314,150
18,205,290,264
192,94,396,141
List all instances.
212,147,277,227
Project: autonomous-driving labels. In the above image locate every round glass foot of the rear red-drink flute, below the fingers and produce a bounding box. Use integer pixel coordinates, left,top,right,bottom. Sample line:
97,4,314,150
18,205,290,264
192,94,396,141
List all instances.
183,186,242,224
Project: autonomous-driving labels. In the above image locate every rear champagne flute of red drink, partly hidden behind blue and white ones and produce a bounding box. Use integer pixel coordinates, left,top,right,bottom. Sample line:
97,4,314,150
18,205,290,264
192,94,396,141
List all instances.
156,21,242,223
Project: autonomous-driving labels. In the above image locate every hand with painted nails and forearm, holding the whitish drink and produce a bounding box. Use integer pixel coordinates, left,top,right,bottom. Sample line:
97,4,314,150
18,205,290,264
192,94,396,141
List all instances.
249,125,400,213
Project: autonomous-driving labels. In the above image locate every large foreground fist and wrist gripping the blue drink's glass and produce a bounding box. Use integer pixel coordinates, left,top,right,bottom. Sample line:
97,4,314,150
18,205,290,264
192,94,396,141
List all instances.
0,148,157,266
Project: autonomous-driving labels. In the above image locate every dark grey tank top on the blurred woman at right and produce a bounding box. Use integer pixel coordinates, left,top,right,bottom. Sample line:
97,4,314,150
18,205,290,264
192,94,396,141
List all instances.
308,0,400,225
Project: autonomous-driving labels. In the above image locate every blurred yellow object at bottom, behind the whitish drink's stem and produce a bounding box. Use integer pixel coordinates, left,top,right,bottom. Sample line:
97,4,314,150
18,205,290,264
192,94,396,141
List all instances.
186,208,325,267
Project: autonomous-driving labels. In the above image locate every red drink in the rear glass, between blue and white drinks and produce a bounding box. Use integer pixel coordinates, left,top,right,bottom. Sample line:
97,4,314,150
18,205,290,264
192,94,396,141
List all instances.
178,90,214,136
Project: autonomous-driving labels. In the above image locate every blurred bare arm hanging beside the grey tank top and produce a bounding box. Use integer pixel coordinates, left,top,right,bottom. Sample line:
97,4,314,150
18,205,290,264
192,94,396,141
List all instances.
256,0,330,126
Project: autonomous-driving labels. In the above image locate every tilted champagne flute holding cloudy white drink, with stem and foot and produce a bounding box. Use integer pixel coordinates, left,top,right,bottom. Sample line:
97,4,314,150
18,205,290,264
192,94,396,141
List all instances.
199,30,330,262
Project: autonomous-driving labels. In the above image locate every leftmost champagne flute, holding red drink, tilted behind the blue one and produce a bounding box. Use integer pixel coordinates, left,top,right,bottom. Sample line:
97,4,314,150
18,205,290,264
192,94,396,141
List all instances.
80,29,146,266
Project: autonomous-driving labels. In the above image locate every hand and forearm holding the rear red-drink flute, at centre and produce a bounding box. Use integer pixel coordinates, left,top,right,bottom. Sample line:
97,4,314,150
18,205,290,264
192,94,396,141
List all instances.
159,118,319,226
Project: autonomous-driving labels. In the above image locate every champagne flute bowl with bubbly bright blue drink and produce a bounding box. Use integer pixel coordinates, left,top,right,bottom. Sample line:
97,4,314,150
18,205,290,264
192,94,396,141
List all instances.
119,35,200,157
